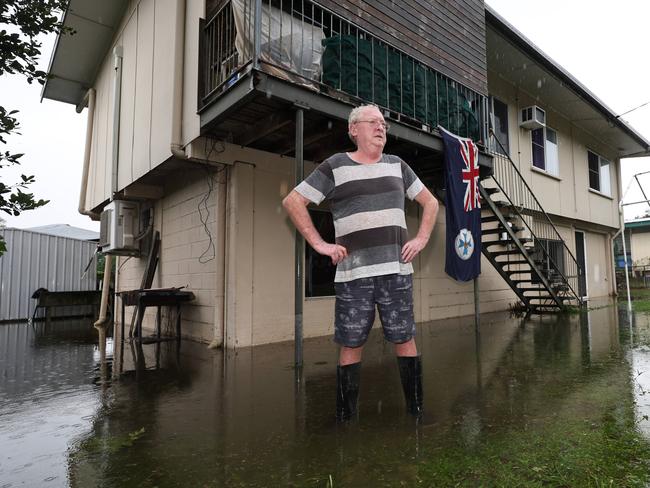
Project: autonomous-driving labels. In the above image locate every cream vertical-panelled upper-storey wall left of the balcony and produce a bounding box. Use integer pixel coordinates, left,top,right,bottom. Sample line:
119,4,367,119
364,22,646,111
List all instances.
86,0,205,212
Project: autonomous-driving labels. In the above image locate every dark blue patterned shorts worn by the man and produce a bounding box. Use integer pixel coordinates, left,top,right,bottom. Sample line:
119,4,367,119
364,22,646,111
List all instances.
334,274,415,347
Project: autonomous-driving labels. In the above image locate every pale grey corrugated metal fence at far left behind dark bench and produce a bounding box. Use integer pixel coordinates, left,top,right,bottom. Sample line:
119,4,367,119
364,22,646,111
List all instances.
0,229,97,320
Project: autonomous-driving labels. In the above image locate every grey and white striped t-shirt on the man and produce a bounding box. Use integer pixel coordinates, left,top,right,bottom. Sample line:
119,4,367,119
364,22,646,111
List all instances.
296,153,424,282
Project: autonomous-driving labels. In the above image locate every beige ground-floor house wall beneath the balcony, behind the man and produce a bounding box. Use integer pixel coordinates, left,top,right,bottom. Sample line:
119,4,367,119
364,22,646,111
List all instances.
118,145,516,347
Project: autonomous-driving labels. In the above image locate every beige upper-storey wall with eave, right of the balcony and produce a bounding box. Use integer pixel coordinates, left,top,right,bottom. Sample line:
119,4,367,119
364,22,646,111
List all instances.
488,71,619,228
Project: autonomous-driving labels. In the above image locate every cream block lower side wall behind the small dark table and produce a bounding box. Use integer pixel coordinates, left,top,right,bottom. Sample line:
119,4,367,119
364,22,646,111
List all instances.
116,165,227,342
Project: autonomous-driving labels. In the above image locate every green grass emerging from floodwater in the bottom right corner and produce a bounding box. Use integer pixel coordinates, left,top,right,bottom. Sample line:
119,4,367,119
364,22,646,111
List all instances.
418,413,650,487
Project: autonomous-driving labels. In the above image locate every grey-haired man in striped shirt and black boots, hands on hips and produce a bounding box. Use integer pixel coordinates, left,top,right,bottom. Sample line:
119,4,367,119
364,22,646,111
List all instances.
282,105,438,421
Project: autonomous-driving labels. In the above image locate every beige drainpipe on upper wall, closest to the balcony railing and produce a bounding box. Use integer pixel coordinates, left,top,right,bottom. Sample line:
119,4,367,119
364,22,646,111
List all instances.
171,0,188,159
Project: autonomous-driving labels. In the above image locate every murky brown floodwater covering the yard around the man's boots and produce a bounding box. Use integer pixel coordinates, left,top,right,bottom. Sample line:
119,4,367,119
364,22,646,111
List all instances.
0,306,650,488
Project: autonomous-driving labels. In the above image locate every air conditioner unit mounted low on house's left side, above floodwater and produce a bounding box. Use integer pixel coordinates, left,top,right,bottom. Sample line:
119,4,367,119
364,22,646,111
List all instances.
99,200,140,256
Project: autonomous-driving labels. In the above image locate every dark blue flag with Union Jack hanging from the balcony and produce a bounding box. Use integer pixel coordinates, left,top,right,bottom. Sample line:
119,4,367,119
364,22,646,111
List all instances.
438,126,481,281
